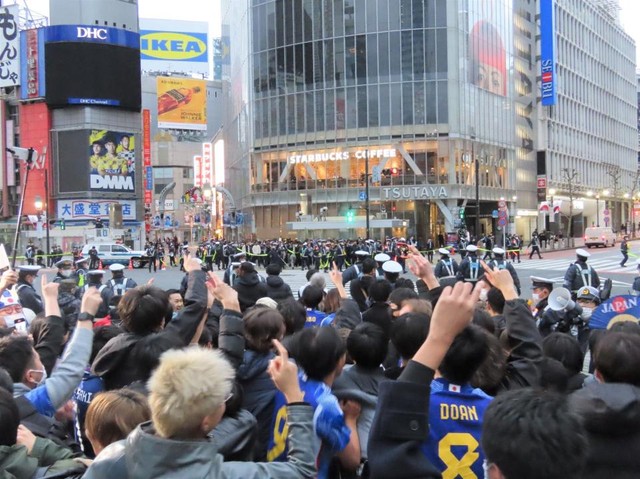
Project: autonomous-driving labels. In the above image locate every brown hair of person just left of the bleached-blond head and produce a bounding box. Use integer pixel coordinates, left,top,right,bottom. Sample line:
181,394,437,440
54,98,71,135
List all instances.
84,389,151,447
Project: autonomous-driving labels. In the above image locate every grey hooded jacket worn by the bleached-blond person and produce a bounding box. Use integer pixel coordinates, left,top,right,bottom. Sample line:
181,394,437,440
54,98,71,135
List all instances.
83,404,316,479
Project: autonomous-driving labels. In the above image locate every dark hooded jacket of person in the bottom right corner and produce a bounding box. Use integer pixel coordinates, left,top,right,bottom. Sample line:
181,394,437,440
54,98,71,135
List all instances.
569,383,640,479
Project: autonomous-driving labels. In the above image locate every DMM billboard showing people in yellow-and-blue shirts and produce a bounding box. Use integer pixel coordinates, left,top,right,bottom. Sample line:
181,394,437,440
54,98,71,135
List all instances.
87,130,136,192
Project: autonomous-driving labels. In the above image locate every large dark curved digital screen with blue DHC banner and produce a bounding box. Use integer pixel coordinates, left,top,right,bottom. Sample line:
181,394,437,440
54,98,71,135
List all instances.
44,25,141,111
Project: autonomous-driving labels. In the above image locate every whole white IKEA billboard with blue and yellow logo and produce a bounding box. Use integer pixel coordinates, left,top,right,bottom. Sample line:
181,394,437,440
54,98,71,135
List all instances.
140,19,209,76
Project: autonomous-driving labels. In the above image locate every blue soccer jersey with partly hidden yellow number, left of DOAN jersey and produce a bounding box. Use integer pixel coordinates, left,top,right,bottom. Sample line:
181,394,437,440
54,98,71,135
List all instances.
267,374,351,479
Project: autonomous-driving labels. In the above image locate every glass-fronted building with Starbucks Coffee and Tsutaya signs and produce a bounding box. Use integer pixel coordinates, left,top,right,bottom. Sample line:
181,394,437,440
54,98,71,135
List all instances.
223,0,536,239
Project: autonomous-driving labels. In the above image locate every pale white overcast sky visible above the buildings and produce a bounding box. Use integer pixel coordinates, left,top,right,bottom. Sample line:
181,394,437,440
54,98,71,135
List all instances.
20,0,640,65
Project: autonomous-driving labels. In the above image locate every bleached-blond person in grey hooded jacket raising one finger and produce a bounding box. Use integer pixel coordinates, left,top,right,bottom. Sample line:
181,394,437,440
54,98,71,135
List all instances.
84,343,316,479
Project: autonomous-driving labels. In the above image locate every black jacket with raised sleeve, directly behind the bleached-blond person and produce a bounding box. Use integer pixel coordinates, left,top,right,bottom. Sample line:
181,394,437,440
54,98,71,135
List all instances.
91,271,207,390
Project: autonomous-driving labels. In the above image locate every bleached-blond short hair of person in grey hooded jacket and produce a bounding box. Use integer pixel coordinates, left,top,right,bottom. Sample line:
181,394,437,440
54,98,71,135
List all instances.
149,346,235,438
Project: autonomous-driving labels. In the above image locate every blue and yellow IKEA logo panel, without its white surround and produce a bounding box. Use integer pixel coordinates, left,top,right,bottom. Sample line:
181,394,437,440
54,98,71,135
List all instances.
140,30,207,62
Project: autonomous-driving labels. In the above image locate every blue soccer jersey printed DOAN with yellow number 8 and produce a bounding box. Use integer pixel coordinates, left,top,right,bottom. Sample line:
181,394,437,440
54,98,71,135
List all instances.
422,378,493,479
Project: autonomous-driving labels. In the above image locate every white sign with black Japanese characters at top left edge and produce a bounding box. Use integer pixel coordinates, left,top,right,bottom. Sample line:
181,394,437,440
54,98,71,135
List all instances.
0,5,20,88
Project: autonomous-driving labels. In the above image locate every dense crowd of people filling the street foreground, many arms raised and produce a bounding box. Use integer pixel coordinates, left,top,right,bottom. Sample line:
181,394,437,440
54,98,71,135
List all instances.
0,239,640,479
